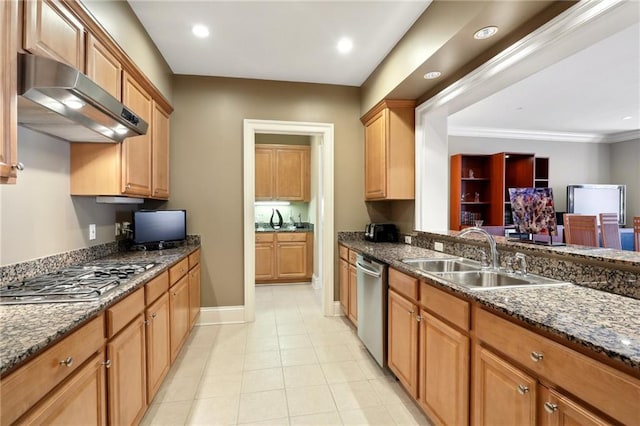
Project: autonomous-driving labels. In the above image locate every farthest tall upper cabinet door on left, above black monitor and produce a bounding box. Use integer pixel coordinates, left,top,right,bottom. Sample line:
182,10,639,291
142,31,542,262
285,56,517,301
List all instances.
151,102,170,199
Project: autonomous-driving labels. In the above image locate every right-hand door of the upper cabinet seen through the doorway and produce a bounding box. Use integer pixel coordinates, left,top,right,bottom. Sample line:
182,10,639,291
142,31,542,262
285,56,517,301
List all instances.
275,147,311,201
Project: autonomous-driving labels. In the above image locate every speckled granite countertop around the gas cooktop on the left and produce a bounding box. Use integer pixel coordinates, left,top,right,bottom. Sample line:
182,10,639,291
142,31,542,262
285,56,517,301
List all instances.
0,245,199,375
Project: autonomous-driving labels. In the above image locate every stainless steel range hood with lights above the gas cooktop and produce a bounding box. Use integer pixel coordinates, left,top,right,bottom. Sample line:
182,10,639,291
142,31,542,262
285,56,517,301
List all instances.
18,53,149,143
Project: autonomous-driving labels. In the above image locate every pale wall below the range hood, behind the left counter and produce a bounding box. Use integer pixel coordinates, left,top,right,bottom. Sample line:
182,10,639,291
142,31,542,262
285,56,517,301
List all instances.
0,127,132,265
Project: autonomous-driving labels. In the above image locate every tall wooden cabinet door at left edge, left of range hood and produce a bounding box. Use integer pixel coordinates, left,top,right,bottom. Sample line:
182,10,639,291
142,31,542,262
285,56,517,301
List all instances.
0,0,18,183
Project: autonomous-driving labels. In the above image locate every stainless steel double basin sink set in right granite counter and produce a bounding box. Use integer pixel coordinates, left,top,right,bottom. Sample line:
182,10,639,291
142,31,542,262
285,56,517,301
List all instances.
403,257,567,290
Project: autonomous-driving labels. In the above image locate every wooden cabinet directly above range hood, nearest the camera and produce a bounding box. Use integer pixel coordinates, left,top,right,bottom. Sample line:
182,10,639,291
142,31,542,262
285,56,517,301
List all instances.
23,0,85,71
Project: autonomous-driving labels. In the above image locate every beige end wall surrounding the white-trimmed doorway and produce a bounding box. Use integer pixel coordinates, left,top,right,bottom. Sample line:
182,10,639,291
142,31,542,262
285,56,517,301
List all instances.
168,76,368,306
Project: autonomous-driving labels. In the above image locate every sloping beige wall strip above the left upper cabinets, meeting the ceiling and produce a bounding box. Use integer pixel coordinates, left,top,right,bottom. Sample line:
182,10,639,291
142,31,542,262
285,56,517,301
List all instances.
81,0,173,102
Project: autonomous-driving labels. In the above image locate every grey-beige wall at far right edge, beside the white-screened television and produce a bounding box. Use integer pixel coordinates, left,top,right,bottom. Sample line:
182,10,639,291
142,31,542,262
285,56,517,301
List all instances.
610,139,640,223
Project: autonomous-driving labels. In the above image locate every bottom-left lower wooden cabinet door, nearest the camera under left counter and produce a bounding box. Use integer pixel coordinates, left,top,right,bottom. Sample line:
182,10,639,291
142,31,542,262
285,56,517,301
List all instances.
20,351,107,425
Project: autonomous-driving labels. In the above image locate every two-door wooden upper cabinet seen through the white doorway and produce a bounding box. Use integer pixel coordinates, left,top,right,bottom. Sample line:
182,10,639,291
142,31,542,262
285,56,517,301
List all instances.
255,144,311,201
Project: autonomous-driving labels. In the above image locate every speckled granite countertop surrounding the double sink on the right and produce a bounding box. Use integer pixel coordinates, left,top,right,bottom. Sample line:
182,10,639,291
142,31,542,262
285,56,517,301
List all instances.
339,239,640,370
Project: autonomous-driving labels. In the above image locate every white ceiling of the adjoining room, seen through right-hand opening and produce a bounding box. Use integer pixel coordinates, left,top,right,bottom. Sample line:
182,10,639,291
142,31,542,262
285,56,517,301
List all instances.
449,23,640,142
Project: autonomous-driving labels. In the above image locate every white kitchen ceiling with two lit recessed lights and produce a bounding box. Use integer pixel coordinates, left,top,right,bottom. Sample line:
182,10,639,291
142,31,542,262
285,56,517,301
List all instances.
129,0,431,86
